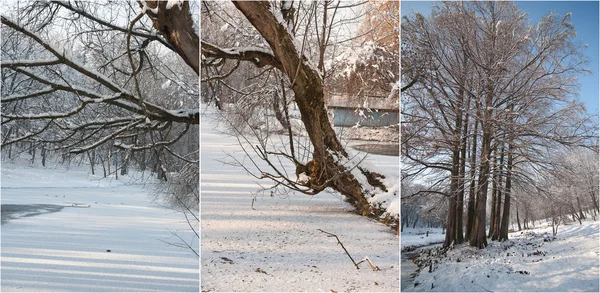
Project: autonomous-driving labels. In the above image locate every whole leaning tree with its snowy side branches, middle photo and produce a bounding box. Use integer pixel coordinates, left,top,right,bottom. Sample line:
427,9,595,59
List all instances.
201,1,398,221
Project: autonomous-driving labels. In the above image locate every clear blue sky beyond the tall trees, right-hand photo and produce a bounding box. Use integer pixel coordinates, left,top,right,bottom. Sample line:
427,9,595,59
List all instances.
400,1,600,113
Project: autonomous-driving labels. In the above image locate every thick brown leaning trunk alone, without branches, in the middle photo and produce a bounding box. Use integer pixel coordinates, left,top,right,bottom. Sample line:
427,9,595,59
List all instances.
233,1,386,216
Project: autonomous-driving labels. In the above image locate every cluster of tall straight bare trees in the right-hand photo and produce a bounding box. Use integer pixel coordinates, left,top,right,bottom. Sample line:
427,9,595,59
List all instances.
401,1,597,248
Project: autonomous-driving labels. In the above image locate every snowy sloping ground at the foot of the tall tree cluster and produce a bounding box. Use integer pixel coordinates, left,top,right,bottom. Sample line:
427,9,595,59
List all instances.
403,220,600,292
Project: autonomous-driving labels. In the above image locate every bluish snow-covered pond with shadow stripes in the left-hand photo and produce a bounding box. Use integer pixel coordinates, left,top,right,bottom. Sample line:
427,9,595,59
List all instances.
1,161,199,292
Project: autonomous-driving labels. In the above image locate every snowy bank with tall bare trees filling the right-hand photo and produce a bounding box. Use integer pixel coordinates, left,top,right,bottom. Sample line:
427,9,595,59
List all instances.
401,1,600,291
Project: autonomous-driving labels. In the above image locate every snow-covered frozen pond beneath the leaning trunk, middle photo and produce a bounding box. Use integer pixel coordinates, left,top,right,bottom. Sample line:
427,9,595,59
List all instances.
201,112,400,292
